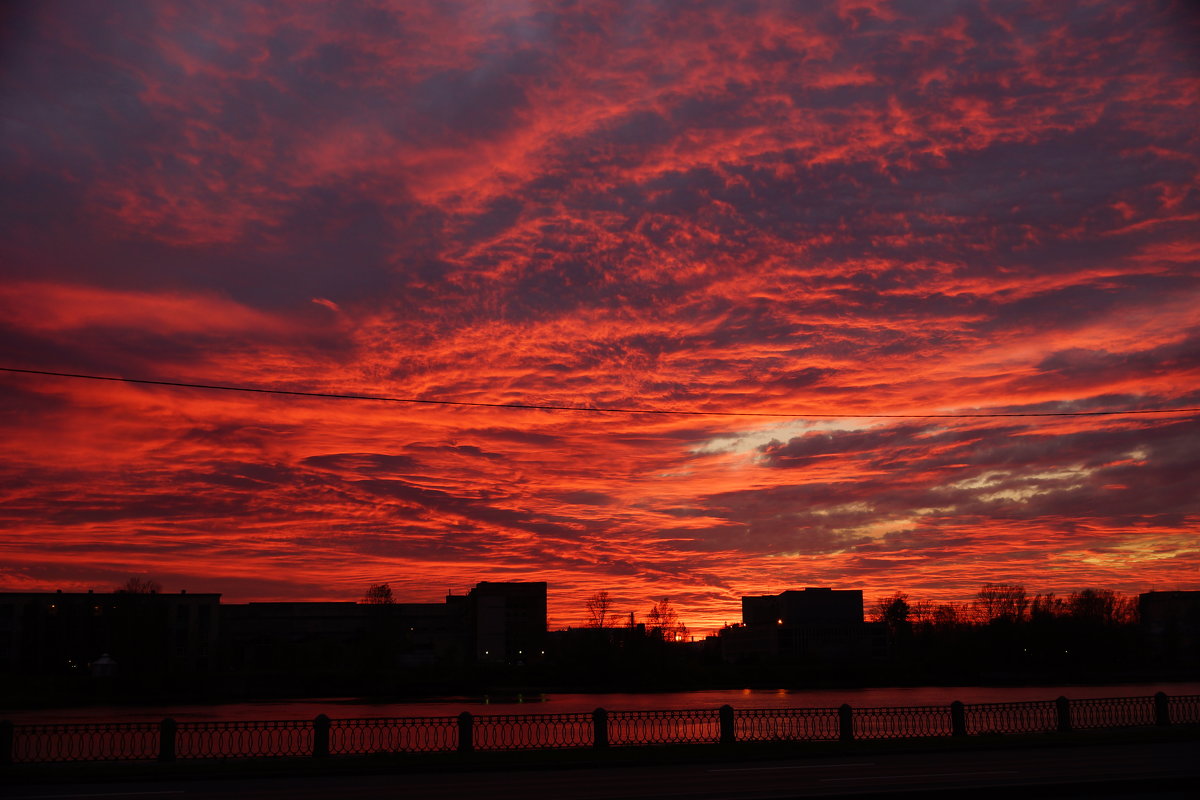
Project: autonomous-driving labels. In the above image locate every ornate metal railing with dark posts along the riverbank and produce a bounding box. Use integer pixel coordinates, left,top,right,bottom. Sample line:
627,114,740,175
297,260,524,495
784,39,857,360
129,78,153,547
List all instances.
0,692,1200,764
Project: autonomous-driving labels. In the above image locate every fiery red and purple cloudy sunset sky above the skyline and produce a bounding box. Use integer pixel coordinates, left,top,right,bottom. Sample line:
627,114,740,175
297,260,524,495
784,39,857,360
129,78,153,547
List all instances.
0,0,1200,632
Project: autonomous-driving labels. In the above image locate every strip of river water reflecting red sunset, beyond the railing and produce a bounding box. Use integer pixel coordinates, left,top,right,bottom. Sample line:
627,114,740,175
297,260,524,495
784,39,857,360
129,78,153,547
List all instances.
9,682,1200,723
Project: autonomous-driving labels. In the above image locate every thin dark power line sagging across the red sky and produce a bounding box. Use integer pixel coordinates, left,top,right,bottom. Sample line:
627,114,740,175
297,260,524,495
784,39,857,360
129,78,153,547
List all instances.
0,367,1200,420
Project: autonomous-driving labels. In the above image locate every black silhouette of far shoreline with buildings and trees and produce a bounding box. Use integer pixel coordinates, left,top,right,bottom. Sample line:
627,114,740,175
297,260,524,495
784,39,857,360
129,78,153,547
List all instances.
0,582,1200,708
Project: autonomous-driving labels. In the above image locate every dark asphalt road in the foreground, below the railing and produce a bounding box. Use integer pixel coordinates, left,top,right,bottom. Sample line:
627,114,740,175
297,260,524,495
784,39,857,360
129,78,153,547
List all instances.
5,741,1200,800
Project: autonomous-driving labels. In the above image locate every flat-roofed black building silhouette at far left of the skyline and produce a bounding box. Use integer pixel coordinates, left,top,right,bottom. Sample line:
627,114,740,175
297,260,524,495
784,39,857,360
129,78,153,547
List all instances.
0,591,221,678
